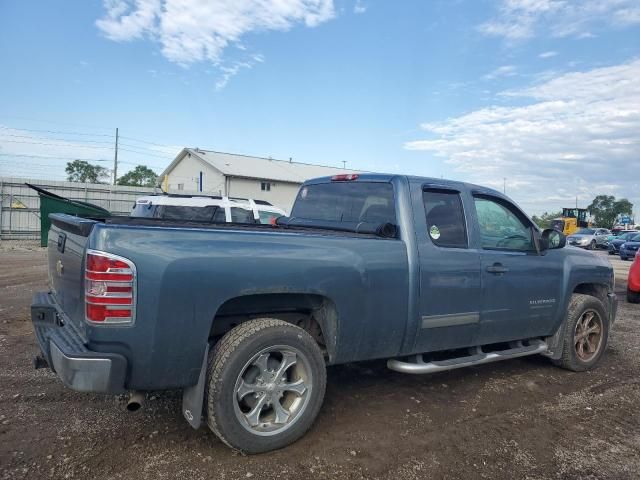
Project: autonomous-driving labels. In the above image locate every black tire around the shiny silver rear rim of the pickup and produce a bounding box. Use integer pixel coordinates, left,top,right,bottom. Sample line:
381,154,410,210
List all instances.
205,318,326,454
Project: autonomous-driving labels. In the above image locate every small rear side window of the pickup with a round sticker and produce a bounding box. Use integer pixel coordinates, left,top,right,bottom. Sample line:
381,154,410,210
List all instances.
422,189,468,248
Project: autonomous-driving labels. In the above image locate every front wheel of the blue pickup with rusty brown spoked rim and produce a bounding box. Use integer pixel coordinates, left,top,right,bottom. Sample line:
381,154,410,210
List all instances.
555,293,609,372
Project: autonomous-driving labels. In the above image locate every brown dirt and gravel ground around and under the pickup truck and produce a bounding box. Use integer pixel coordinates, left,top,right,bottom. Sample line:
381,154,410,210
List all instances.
0,242,640,480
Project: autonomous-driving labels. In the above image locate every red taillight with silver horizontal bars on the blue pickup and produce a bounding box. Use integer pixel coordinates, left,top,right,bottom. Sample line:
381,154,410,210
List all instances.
84,251,135,323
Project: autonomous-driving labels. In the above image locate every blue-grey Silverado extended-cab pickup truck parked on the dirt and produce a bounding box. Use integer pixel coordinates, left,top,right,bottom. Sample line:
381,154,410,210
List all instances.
31,174,617,453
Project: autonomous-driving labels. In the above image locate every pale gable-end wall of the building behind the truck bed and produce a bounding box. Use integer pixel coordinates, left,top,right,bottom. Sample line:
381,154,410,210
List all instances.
168,155,225,195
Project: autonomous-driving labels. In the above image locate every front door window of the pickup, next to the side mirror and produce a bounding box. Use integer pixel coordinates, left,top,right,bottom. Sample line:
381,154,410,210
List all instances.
474,196,535,251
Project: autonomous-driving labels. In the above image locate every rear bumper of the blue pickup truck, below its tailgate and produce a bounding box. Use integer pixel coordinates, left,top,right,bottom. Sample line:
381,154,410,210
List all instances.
31,292,127,394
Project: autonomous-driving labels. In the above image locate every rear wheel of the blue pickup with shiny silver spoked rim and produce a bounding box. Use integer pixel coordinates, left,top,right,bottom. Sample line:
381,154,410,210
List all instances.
206,318,326,453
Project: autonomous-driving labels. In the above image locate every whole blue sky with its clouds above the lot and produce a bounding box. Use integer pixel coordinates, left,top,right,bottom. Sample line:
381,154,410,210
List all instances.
0,0,640,213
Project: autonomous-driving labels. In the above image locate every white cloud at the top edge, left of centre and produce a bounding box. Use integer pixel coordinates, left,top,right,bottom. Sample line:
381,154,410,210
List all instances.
96,0,335,65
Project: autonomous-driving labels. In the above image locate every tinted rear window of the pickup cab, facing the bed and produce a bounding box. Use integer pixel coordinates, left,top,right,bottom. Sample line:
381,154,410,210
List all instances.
291,182,396,224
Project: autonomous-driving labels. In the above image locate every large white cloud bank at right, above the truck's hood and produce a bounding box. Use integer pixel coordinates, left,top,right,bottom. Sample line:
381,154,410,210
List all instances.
404,60,640,211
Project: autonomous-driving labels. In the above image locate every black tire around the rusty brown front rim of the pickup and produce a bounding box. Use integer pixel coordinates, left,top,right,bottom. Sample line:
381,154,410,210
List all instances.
554,293,609,372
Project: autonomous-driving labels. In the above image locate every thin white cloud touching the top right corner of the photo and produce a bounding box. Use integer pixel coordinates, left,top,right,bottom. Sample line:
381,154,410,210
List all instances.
478,0,640,41
